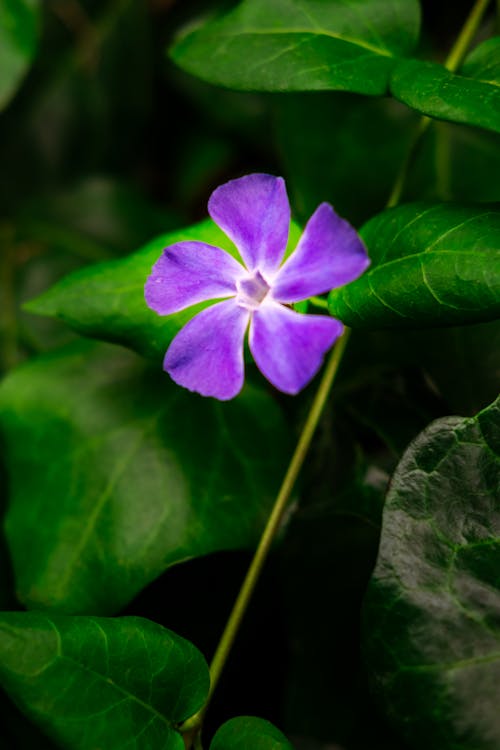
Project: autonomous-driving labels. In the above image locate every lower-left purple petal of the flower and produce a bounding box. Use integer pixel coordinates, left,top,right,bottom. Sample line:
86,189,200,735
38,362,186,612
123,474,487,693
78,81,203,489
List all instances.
163,299,250,401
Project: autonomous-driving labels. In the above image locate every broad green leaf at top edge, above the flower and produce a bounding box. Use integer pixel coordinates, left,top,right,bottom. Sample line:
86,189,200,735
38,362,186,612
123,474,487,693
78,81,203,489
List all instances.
171,0,419,95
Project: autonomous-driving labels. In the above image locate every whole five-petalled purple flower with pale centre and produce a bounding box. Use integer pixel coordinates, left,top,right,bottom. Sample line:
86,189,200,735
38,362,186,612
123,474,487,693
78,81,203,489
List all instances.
145,174,370,401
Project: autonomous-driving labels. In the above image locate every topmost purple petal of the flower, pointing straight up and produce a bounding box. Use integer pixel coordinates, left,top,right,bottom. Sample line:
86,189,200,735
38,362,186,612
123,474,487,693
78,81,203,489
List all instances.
208,174,290,274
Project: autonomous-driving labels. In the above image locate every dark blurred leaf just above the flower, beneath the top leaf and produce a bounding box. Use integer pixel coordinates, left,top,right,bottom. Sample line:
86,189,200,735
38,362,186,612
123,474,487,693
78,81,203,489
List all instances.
275,93,416,225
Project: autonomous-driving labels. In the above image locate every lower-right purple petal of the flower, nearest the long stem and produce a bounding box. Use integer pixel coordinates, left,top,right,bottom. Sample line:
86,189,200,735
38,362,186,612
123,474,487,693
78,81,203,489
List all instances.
249,301,343,394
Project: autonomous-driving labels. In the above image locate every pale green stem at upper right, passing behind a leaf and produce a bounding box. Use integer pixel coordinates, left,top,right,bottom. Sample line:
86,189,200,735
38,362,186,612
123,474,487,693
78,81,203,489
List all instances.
386,0,490,208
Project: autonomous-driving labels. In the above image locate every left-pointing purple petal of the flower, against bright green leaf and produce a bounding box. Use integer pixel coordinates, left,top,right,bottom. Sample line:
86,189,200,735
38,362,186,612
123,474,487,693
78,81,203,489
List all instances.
144,241,246,315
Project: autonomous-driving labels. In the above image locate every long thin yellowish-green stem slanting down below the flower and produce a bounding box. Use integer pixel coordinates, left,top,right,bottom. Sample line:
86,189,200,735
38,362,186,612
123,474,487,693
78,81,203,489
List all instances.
180,328,350,733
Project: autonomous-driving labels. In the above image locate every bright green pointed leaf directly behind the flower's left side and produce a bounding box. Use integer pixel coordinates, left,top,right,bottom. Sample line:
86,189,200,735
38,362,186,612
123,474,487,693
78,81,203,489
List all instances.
25,219,300,360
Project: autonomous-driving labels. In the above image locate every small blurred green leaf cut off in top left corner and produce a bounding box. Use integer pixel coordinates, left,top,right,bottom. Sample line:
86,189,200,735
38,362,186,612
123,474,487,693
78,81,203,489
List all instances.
0,0,40,109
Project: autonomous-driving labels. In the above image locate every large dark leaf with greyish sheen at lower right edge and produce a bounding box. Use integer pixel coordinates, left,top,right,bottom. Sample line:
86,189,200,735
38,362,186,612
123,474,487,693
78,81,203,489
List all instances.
364,401,500,750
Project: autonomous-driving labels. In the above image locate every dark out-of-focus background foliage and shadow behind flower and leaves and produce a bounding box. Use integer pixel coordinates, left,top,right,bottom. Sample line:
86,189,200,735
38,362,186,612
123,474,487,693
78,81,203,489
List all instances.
0,0,500,750
